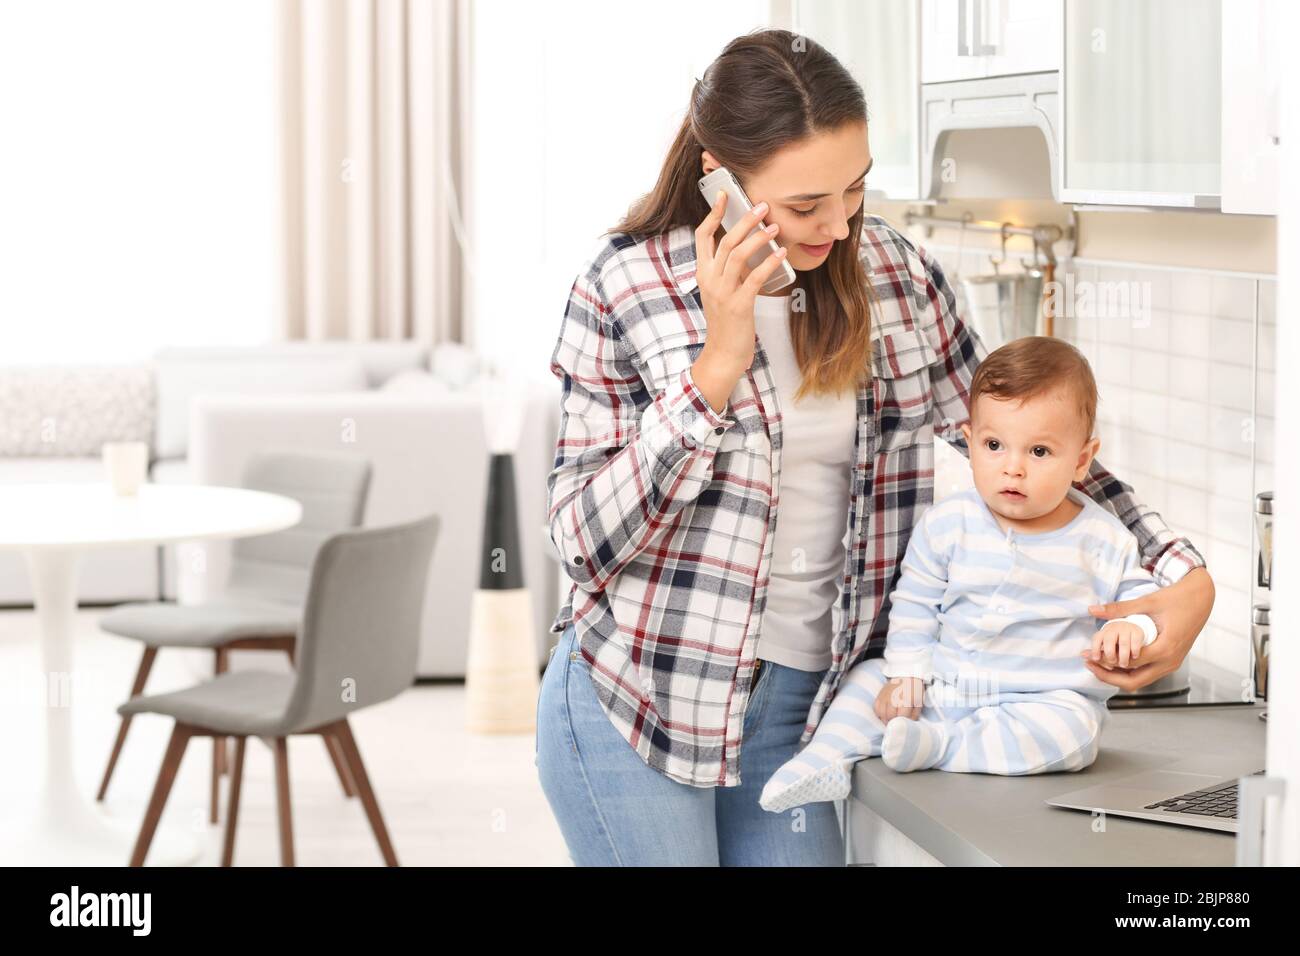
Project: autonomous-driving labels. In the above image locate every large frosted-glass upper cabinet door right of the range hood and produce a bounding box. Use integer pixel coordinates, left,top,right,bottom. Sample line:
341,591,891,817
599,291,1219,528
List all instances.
1058,0,1235,208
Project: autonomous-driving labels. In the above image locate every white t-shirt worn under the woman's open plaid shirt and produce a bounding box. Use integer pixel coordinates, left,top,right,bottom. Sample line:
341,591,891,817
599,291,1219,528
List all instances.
754,295,857,671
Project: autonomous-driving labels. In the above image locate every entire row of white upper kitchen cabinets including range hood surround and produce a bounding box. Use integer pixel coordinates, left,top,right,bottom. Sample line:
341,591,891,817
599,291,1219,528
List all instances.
842,0,1268,215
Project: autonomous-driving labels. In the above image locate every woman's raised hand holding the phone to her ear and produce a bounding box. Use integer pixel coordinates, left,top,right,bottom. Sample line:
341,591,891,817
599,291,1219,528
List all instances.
696,190,785,378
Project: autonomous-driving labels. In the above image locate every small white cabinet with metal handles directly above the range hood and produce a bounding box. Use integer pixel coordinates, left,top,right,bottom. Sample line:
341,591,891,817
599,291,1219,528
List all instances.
920,0,1061,83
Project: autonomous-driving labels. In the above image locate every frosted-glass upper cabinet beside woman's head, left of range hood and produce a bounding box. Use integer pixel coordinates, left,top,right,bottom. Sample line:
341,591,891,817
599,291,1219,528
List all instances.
793,0,920,200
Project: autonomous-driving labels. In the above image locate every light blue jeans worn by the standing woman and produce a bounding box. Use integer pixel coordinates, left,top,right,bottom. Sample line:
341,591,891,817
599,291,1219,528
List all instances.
534,624,845,866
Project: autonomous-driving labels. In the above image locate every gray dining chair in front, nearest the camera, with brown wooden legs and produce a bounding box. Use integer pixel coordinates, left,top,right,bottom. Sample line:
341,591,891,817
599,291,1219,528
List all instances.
117,515,438,866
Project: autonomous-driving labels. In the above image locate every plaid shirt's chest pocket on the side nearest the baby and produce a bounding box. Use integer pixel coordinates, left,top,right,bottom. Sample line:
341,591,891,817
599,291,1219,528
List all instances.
872,329,936,451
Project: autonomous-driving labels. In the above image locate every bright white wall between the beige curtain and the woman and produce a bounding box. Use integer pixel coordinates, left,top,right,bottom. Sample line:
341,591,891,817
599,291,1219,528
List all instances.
471,0,768,382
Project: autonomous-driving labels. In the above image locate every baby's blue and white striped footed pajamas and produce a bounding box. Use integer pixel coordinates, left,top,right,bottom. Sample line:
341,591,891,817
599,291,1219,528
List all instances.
759,488,1158,812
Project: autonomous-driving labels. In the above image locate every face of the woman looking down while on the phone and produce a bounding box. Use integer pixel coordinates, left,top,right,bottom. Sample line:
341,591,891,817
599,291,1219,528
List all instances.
703,122,874,269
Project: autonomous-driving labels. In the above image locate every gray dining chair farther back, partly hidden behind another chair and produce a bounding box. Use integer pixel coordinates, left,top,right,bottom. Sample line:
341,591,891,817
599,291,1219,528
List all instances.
95,451,371,823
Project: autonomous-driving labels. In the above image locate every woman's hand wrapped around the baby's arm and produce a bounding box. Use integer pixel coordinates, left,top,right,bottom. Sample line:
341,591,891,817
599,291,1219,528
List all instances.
1084,567,1214,692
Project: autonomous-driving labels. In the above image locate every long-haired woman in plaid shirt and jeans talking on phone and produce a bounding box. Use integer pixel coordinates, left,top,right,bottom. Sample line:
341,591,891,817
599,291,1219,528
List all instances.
537,30,1213,865
